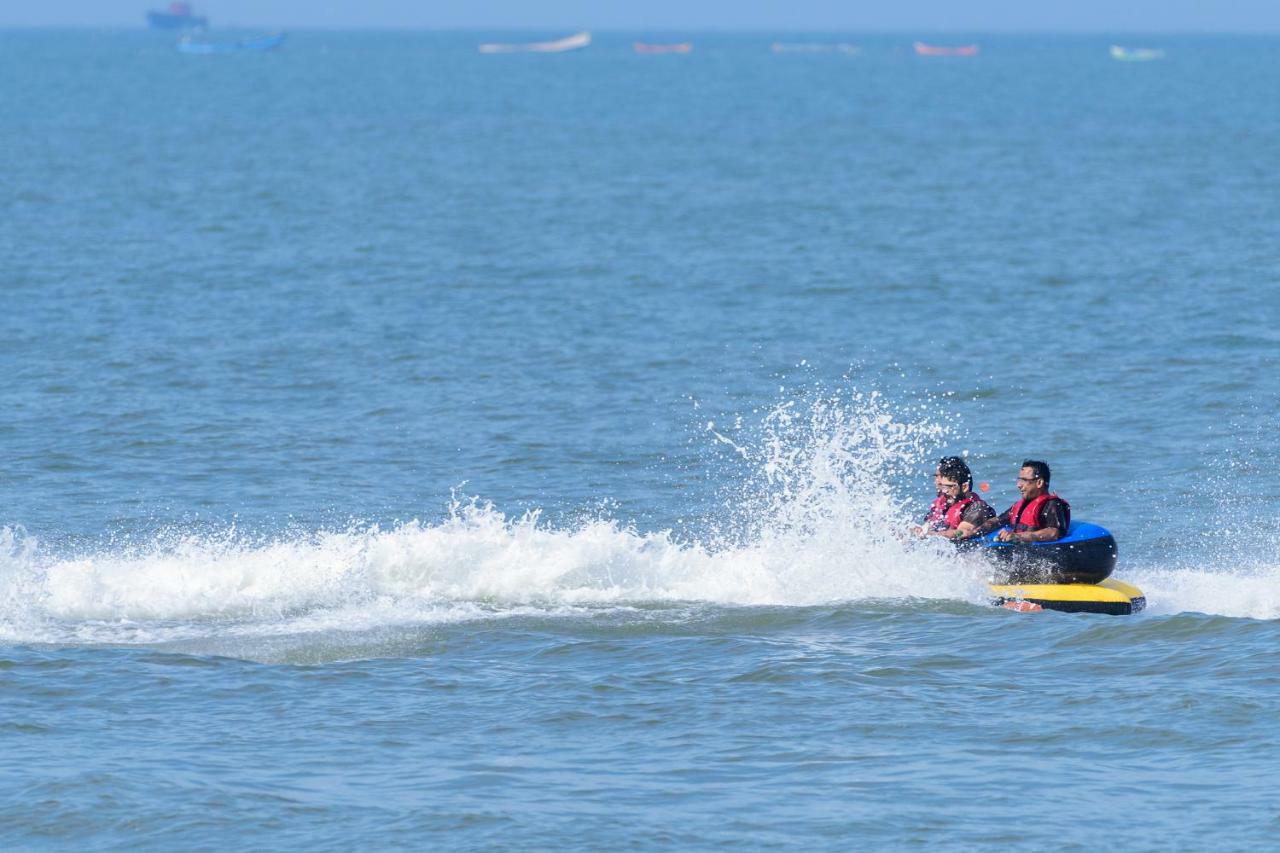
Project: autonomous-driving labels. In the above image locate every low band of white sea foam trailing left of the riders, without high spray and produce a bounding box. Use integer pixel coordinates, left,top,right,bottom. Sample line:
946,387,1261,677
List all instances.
0,503,982,642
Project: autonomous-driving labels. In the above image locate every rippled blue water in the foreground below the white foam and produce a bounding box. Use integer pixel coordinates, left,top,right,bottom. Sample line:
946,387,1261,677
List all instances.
0,605,1277,847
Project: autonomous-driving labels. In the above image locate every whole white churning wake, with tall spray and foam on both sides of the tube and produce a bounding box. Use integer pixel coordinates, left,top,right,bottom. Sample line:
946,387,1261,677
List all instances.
0,393,1280,644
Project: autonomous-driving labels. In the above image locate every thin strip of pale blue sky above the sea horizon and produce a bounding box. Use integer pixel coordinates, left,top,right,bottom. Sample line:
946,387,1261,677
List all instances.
0,0,1280,33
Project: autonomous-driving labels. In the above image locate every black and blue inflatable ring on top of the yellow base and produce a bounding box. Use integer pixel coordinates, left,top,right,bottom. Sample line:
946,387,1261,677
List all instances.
972,521,1116,585
